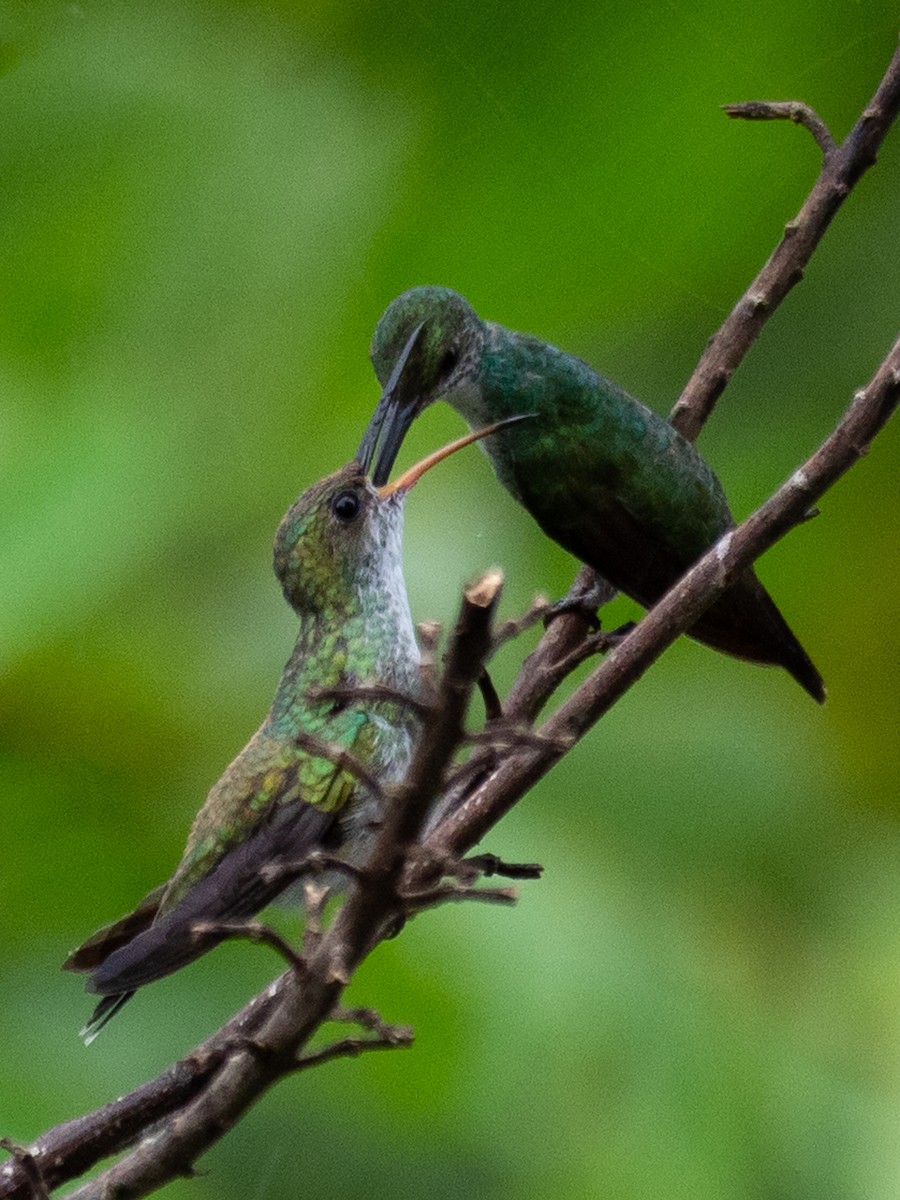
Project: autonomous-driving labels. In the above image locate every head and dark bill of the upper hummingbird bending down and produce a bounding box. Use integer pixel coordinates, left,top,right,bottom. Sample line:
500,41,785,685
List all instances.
356,287,485,485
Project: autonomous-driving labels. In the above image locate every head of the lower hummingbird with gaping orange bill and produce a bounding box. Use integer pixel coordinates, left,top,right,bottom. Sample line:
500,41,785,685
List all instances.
274,416,521,616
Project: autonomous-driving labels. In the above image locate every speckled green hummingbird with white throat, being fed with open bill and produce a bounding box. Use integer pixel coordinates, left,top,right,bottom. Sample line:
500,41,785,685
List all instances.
64,424,518,1043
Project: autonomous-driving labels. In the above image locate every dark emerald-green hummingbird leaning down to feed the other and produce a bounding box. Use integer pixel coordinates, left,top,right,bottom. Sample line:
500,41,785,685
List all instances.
359,287,826,703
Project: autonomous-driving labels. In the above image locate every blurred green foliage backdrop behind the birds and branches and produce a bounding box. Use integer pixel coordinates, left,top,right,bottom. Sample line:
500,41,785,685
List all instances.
0,0,900,1200
